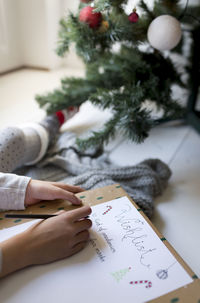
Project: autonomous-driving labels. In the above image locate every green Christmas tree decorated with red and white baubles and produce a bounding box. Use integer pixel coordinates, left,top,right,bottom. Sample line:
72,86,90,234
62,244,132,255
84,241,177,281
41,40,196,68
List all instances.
36,0,200,149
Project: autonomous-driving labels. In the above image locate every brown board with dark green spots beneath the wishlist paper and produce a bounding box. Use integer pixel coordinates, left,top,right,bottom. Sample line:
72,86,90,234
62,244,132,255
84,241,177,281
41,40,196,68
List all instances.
0,184,200,303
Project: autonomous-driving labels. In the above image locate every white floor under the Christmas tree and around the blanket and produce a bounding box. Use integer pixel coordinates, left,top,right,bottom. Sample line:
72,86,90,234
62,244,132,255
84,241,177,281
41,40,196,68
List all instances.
0,69,200,276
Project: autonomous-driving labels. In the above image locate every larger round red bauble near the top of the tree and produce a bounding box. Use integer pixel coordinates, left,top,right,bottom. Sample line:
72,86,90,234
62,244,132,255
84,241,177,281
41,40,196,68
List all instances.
79,6,102,28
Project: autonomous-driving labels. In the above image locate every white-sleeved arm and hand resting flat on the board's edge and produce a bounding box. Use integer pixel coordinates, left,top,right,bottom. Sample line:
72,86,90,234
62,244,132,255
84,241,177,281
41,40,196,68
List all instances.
0,173,83,210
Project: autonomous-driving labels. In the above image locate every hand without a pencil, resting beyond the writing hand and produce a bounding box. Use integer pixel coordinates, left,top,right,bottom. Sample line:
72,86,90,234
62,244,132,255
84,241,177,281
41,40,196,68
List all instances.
24,180,84,206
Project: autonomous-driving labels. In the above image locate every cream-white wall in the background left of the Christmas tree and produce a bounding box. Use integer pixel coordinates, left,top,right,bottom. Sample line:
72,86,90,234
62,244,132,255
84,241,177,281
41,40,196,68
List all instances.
0,0,79,73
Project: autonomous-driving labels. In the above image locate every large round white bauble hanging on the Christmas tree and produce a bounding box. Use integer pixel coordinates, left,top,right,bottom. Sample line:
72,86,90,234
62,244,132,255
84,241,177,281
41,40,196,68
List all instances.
147,15,182,51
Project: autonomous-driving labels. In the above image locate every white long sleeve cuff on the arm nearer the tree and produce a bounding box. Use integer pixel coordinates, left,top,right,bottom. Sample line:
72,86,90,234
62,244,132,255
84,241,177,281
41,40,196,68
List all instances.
0,173,30,210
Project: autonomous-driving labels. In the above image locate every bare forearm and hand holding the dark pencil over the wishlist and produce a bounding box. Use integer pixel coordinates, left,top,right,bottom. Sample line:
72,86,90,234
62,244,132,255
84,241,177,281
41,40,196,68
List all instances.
0,206,92,278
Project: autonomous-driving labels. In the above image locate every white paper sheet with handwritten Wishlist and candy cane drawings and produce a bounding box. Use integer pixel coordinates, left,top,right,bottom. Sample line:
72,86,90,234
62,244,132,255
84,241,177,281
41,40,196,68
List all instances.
0,197,193,303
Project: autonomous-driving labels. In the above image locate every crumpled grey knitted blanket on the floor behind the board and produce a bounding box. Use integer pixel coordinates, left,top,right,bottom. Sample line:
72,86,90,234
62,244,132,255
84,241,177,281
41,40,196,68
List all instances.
17,132,171,217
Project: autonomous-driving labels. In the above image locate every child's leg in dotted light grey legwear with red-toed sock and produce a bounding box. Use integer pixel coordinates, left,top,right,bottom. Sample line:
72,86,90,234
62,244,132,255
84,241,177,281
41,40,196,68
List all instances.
0,108,77,173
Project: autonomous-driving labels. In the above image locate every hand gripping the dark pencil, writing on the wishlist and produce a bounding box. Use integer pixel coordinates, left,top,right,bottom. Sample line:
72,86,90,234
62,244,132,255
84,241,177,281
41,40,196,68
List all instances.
26,206,92,265
